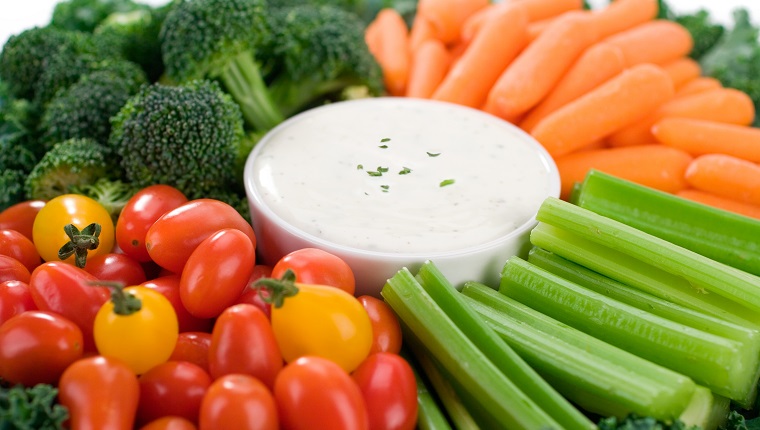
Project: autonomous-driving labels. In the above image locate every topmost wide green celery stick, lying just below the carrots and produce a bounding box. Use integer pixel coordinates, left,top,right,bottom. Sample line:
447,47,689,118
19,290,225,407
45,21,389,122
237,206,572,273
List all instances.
574,171,760,275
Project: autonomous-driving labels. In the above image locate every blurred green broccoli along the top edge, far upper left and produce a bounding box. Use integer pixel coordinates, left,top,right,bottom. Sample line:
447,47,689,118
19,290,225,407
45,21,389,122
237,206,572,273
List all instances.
50,0,148,32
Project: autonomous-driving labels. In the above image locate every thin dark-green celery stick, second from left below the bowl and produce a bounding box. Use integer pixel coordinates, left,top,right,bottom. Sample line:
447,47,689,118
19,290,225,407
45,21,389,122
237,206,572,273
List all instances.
416,261,594,429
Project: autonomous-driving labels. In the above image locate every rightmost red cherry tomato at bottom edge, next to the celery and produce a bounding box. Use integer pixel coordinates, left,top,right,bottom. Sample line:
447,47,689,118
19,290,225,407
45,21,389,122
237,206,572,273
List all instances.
351,352,417,430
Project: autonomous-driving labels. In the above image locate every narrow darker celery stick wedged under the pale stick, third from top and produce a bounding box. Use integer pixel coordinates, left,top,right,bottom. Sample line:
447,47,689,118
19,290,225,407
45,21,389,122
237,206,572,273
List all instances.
528,247,760,350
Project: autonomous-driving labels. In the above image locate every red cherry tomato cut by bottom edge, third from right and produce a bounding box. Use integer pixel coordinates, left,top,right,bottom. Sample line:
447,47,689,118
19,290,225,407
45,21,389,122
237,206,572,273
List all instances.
198,375,279,430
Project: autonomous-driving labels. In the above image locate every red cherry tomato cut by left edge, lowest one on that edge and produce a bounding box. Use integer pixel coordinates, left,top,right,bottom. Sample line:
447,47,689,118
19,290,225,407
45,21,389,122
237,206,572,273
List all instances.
0,311,83,387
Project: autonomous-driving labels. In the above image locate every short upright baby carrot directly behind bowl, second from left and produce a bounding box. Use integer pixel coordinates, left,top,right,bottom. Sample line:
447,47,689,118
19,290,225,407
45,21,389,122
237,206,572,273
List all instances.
406,39,451,98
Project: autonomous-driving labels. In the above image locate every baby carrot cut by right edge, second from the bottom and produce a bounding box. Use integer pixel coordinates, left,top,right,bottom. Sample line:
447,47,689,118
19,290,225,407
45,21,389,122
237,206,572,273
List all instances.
684,154,760,206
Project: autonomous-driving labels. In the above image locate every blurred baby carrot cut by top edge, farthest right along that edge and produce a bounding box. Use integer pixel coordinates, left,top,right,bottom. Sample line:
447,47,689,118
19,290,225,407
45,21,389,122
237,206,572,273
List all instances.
592,0,659,39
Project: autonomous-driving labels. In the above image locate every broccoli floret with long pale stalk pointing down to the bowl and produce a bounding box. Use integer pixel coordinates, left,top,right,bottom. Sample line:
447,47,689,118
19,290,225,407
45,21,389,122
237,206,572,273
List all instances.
161,0,284,130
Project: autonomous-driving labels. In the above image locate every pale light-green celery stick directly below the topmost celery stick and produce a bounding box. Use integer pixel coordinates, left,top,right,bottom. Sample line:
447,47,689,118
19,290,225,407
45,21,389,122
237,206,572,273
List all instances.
536,197,760,318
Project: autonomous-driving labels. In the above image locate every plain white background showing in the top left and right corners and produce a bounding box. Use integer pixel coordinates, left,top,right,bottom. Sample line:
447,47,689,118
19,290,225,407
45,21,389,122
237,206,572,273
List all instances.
0,0,760,44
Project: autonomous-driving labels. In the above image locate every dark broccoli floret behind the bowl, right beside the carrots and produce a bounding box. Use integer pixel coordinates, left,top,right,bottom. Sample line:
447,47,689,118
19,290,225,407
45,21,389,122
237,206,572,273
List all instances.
270,5,383,117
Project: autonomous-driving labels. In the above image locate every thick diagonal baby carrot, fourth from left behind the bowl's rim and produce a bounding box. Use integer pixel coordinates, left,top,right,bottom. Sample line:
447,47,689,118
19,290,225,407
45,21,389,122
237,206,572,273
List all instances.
488,10,600,118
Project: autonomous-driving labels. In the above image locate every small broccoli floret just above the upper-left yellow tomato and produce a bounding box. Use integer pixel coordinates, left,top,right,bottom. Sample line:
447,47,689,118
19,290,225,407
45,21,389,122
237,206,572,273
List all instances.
25,139,119,200
